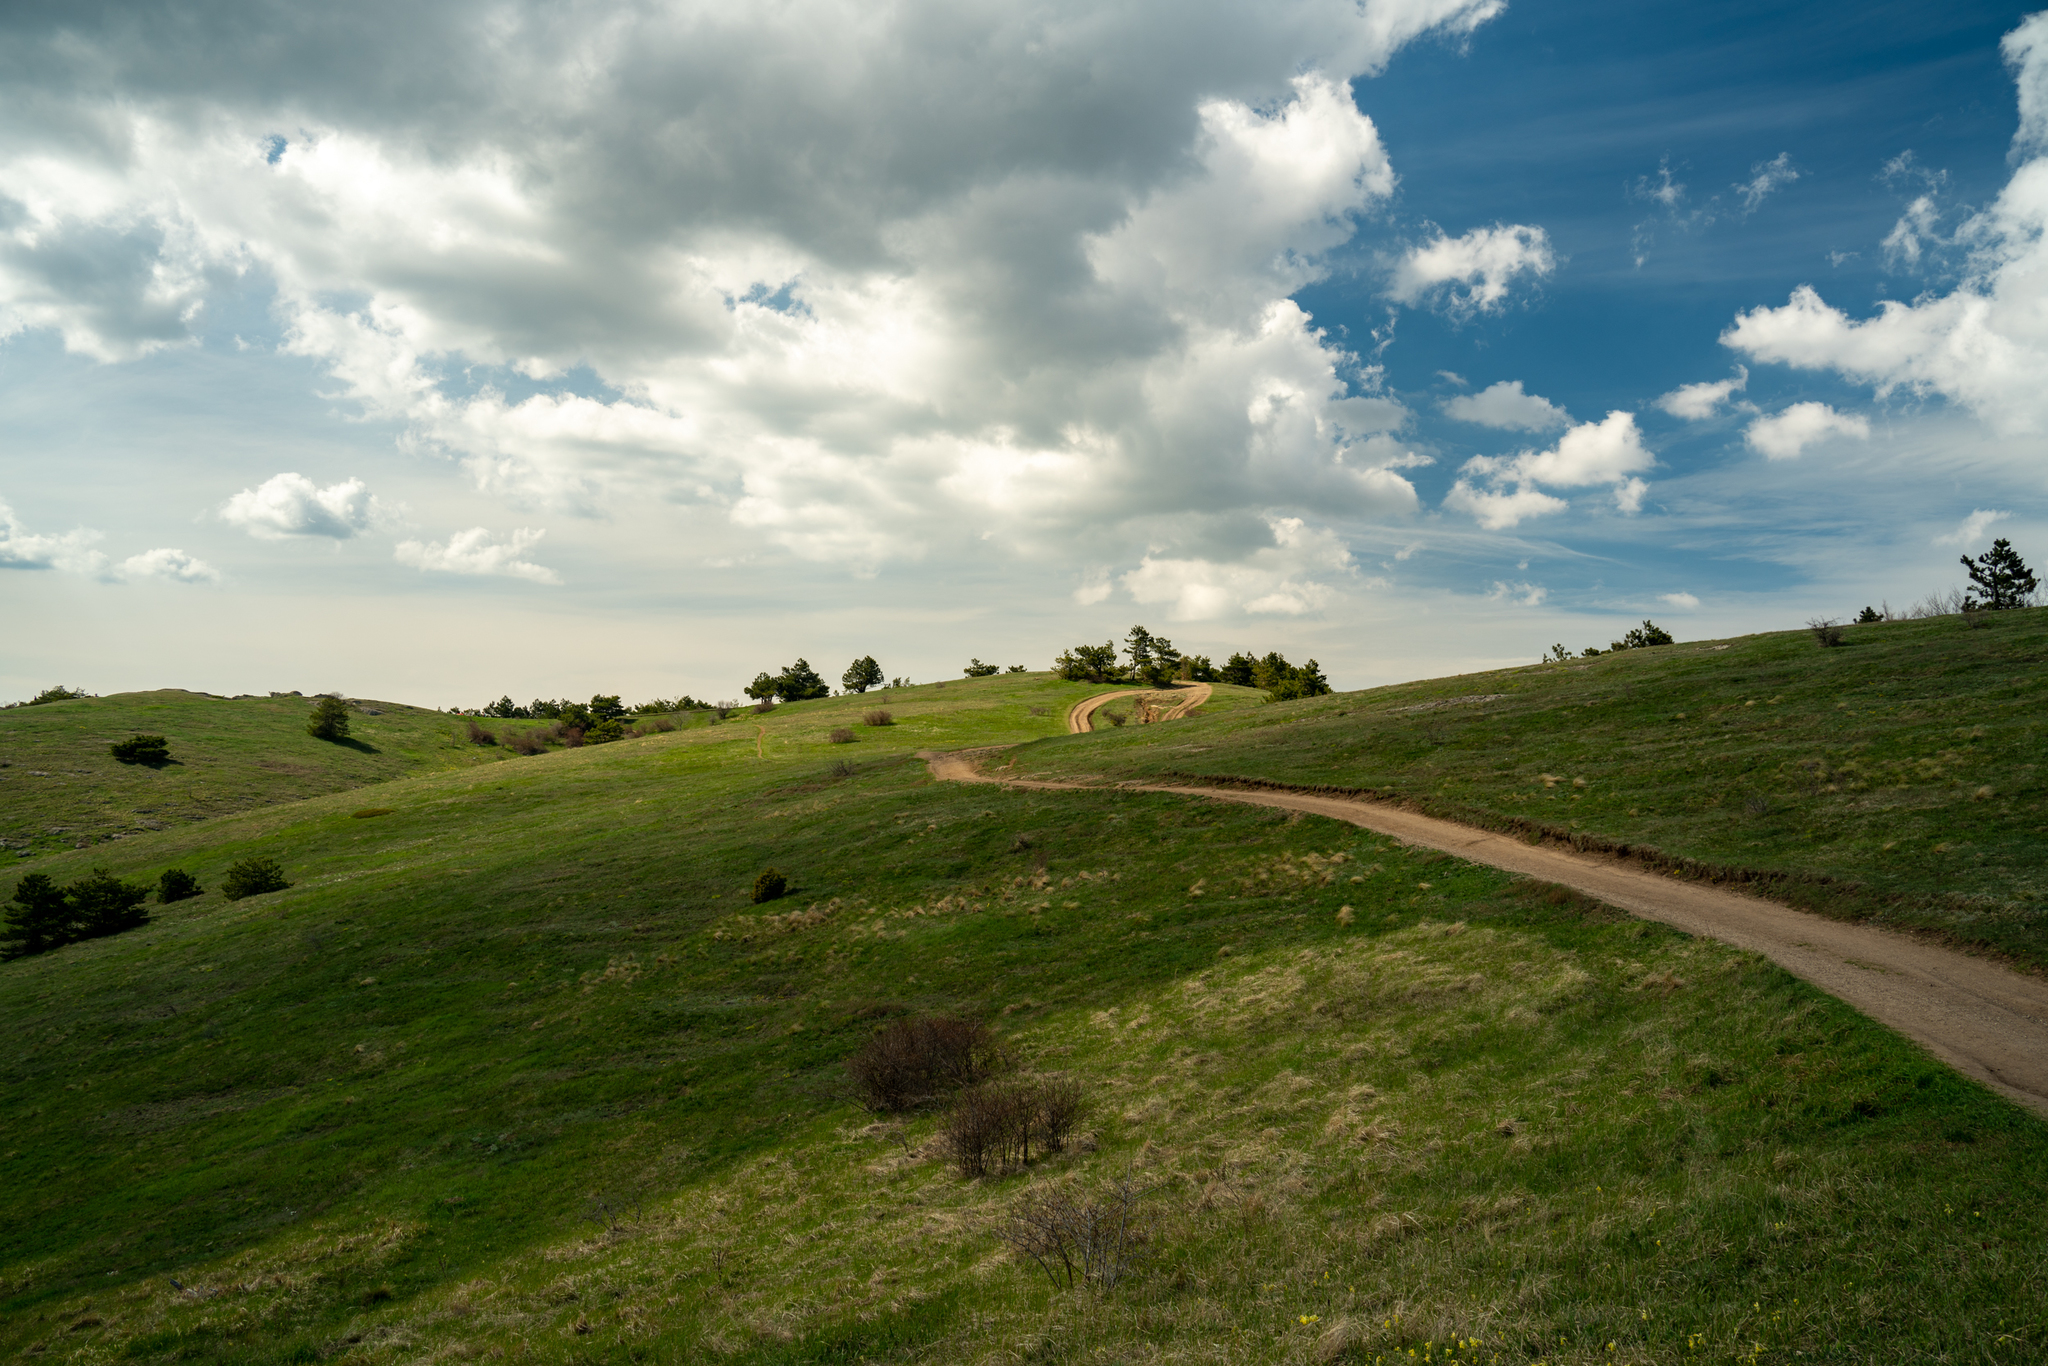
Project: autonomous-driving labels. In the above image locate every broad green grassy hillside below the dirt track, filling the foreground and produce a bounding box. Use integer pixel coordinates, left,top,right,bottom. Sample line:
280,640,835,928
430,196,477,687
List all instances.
0,676,2048,1362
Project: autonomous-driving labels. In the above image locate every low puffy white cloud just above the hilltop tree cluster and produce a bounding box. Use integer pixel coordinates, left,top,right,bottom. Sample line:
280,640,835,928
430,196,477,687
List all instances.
1120,518,1358,621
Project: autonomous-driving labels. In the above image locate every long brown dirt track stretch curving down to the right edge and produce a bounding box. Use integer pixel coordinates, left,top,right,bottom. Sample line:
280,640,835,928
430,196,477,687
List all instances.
922,749,2048,1116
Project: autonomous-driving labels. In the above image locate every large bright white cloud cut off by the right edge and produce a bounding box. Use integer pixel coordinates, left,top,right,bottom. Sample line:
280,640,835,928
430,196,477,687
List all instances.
1720,14,2048,434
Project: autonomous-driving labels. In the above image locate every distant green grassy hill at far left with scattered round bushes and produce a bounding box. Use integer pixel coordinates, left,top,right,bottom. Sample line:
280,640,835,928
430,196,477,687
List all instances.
0,688,528,868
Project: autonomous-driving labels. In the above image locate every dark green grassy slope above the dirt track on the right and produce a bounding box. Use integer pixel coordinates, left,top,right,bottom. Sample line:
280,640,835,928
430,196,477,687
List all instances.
1016,608,2048,967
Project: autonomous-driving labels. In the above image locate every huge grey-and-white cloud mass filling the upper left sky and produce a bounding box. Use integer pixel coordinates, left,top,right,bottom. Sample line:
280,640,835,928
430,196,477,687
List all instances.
0,0,1507,571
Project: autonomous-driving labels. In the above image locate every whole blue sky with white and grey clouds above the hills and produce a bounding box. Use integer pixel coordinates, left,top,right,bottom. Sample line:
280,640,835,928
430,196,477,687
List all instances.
0,0,2048,707
